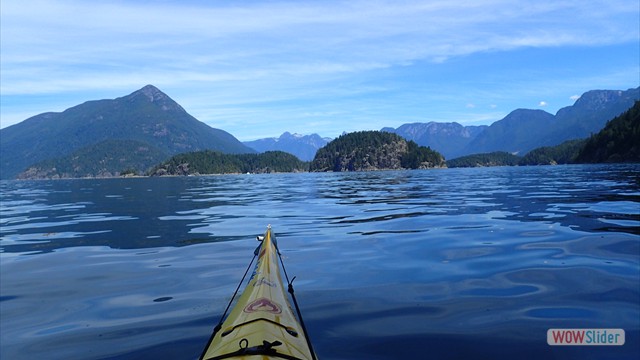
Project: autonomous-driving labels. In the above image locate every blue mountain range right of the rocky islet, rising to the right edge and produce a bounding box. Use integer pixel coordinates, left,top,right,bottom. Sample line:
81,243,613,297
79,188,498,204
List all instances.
382,87,640,159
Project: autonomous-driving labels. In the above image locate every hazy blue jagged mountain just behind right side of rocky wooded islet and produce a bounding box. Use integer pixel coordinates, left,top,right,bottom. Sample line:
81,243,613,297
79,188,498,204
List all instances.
381,121,488,159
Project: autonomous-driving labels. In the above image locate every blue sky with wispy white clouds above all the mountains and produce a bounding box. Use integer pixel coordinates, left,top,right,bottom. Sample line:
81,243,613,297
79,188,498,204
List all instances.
0,0,640,141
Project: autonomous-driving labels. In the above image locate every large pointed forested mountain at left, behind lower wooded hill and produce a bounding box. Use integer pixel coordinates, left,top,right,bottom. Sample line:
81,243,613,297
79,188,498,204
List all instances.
0,85,254,179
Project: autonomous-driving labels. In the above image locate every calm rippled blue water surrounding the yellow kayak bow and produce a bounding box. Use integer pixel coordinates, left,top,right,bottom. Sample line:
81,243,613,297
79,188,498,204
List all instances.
0,165,640,360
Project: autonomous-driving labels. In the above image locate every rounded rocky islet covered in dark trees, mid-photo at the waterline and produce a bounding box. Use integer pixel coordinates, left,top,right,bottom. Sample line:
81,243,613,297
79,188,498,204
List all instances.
309,131,445,171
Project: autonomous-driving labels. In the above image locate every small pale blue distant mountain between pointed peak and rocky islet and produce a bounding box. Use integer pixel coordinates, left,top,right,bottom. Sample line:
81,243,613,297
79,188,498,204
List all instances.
243,132,331,161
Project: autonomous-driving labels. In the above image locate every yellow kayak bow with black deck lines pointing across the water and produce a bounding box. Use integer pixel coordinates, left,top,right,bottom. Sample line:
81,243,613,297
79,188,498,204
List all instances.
200,225,317,360
